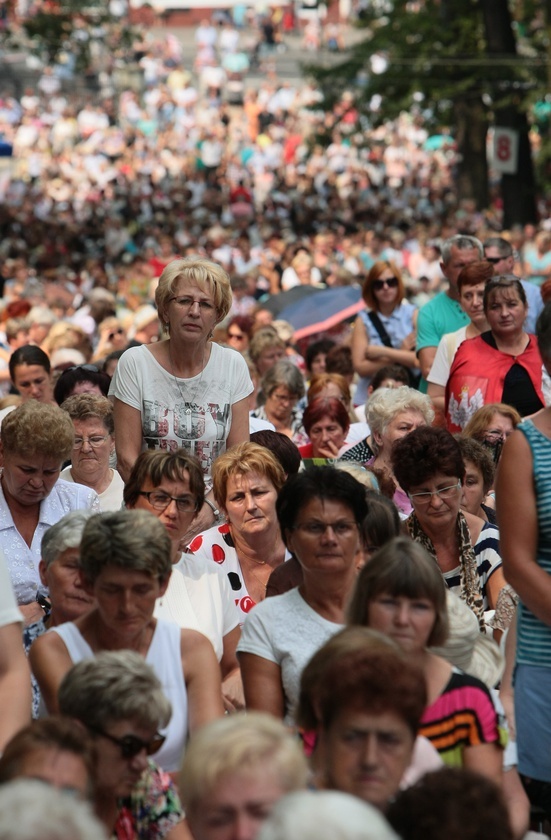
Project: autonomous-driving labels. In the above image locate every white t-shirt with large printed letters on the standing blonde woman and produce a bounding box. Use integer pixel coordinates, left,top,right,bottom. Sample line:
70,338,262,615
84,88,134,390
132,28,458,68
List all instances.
109,342,253,489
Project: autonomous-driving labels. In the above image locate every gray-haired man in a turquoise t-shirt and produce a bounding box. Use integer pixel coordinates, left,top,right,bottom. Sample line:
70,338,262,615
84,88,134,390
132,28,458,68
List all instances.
416,234,484,393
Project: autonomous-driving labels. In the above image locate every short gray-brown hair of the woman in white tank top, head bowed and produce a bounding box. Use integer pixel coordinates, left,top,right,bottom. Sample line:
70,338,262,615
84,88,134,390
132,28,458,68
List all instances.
80,510,172,583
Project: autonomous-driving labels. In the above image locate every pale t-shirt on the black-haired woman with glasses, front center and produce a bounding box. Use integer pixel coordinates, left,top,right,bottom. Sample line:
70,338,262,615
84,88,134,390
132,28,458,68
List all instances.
237,588,342,724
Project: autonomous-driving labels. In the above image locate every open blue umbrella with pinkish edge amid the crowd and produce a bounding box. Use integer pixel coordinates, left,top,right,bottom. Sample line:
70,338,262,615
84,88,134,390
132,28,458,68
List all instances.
278,286,365,341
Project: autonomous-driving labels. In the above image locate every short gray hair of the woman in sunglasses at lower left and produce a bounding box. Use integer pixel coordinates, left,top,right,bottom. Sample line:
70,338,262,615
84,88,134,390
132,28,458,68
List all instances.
58,650,172,729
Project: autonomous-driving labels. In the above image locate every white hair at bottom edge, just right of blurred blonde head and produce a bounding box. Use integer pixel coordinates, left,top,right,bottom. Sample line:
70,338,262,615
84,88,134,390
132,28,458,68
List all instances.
258,790,398,840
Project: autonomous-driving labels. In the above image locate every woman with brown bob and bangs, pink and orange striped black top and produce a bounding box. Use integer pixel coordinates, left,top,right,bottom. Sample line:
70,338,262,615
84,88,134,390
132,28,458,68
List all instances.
348,537,502,781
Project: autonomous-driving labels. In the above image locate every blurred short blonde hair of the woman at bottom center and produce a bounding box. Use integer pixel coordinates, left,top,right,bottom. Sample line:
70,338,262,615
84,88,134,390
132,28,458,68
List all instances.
179,712,308,817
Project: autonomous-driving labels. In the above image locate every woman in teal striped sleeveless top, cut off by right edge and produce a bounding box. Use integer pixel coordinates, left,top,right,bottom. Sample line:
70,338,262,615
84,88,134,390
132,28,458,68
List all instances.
496,304,551,818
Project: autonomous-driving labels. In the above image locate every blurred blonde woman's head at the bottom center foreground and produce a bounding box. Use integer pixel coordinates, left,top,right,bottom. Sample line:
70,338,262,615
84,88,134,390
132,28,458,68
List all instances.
179,712,308,840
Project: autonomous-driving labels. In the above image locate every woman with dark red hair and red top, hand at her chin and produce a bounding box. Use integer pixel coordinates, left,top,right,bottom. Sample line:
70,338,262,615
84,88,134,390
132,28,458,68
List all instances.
298,398,350,459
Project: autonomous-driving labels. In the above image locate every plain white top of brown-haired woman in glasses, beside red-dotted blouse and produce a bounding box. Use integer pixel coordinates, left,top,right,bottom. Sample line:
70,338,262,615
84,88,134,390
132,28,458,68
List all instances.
154,554,239,661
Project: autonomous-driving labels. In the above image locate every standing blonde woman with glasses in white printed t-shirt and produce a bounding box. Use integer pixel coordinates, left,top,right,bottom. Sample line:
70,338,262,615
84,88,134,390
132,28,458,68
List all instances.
109,256,252,512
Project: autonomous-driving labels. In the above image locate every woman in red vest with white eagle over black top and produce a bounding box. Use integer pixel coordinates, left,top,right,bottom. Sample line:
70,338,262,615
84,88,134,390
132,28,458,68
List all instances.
446,274,544,432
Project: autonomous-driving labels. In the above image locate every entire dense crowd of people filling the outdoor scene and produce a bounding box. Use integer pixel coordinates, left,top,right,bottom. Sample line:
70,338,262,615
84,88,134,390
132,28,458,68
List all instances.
0,15,551,840
